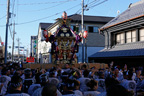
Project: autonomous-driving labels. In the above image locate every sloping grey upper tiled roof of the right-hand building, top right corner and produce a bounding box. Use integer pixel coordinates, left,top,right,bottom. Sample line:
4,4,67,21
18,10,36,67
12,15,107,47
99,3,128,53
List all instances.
100,0,144,30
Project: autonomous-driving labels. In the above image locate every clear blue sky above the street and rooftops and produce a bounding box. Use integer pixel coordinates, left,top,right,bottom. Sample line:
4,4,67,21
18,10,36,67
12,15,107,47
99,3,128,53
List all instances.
0,0,140,52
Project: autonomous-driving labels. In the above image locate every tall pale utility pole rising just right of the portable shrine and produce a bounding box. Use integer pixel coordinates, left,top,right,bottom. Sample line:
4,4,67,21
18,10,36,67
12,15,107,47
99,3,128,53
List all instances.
81,0,84,63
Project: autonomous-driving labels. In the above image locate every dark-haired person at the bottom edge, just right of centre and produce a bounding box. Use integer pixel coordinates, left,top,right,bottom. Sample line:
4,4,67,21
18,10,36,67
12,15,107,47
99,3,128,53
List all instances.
84,80,100,96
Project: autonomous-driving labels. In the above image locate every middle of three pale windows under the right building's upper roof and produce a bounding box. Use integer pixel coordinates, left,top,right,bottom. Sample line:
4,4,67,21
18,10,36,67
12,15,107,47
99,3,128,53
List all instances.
126,30,136,43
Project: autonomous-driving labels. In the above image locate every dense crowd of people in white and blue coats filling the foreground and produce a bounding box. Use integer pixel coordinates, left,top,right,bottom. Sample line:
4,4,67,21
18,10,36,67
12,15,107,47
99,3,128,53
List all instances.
0,63,144,96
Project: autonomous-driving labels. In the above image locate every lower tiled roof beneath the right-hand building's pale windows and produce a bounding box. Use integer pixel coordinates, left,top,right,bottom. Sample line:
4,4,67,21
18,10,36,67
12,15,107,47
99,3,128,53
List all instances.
90,42,144,57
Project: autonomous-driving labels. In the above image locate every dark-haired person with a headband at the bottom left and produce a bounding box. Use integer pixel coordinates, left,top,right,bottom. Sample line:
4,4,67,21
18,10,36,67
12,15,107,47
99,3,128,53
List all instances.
6,75,30,96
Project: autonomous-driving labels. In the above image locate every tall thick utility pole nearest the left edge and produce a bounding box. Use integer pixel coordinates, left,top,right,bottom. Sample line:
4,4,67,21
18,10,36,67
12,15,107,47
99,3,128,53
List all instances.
4,0,10,64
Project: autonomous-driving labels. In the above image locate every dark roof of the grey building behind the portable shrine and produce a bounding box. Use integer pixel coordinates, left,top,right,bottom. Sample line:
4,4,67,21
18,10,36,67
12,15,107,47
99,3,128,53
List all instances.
68,14,114,23
